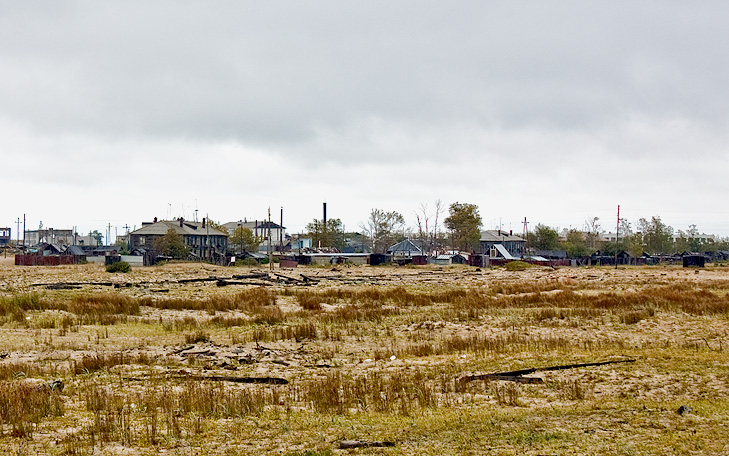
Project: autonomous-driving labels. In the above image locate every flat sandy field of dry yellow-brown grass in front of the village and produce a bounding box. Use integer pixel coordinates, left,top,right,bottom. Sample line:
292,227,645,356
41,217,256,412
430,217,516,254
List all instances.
0,261,729,456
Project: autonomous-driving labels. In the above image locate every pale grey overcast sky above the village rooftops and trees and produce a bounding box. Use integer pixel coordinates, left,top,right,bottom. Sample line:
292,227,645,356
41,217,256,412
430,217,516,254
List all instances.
0,0,729,242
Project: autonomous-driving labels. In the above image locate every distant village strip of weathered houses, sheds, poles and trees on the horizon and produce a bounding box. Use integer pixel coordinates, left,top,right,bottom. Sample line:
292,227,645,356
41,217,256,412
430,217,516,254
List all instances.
0,203,729,267
